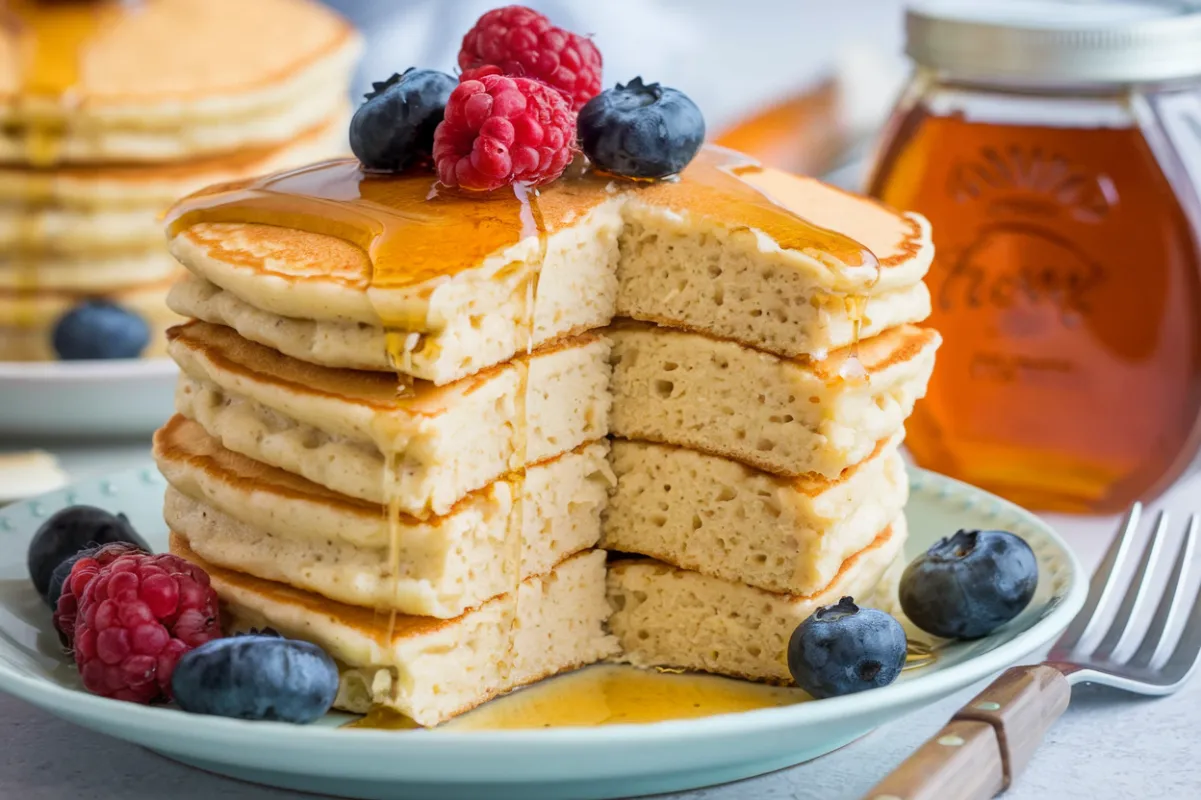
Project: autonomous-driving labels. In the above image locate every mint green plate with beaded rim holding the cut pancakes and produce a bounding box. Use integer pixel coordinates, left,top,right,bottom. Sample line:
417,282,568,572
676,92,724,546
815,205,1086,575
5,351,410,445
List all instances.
0,466,1087,800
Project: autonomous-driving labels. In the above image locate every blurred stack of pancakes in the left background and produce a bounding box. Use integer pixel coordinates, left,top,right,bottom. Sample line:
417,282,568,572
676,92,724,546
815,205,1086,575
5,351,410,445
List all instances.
0,0,359,360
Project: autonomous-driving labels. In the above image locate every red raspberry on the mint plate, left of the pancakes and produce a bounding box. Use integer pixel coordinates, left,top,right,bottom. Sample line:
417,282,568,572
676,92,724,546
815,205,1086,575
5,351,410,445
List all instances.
71,554,221,703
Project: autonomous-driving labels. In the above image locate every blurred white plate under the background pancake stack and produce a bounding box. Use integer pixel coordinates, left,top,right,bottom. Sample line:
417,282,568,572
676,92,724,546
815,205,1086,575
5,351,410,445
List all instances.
0,358,178,440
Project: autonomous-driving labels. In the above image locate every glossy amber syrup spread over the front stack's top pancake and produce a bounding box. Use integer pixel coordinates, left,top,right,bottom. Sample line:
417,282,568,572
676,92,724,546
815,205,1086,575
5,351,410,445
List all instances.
167,147,878,293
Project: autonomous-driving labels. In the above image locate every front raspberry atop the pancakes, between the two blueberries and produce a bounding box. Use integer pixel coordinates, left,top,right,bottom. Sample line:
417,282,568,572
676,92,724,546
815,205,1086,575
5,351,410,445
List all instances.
434,74,575,191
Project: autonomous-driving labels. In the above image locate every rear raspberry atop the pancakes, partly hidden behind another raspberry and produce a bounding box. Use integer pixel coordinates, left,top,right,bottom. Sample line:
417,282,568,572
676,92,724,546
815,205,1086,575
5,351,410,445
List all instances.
459,6,602,111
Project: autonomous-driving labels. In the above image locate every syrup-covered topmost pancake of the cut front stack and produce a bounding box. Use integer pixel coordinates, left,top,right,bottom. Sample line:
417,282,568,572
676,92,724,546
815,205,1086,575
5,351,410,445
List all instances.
157,148,933,382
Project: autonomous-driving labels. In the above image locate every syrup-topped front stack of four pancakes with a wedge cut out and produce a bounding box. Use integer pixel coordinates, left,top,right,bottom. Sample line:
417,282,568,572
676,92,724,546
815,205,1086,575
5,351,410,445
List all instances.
155,148,939,726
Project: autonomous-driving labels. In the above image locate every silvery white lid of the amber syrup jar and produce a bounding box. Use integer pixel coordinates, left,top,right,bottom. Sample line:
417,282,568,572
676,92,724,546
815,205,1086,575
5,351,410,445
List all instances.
906,0,1201,85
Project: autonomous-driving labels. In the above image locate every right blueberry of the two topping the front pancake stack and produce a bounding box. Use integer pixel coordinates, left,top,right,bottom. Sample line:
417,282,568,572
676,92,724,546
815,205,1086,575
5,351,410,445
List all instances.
579,78,705,178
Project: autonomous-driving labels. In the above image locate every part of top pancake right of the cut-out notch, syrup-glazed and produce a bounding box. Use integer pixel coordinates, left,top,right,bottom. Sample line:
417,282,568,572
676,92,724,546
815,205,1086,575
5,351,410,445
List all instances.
617,151,933,357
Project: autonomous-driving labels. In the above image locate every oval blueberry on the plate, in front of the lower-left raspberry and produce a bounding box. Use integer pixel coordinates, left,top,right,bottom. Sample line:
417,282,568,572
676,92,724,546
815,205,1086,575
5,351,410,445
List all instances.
171,631,337,724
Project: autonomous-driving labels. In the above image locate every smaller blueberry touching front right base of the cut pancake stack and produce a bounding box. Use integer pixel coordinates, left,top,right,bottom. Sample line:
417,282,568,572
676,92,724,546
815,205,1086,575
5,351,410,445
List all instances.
788,597,906,699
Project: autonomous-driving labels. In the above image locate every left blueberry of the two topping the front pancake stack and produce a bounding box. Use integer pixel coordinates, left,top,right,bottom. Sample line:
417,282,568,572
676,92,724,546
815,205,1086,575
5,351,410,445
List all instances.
351,67,459,172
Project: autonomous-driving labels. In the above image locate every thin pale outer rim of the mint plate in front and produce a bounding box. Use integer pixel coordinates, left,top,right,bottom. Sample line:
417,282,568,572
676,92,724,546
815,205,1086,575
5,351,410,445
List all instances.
0,459,1088,756
